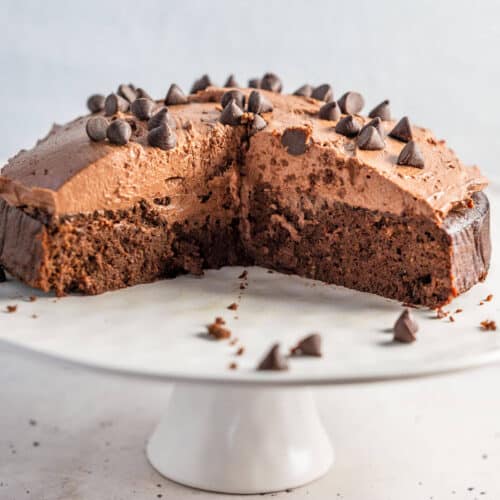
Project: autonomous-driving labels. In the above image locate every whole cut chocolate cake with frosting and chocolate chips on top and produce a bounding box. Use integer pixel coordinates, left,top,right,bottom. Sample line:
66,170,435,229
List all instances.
0,74,490,307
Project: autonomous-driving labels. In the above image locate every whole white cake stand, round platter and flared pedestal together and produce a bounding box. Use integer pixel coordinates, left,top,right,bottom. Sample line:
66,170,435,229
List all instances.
0,187,500,493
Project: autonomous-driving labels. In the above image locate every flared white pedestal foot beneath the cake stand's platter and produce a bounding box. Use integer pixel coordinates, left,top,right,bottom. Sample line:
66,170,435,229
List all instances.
147,384,334,494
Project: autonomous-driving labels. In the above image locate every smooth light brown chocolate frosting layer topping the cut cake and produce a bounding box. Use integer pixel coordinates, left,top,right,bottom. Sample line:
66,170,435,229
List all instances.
0,76,487,221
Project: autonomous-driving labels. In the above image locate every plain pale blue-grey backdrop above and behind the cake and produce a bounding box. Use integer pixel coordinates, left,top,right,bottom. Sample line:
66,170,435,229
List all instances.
0,0,500,178
